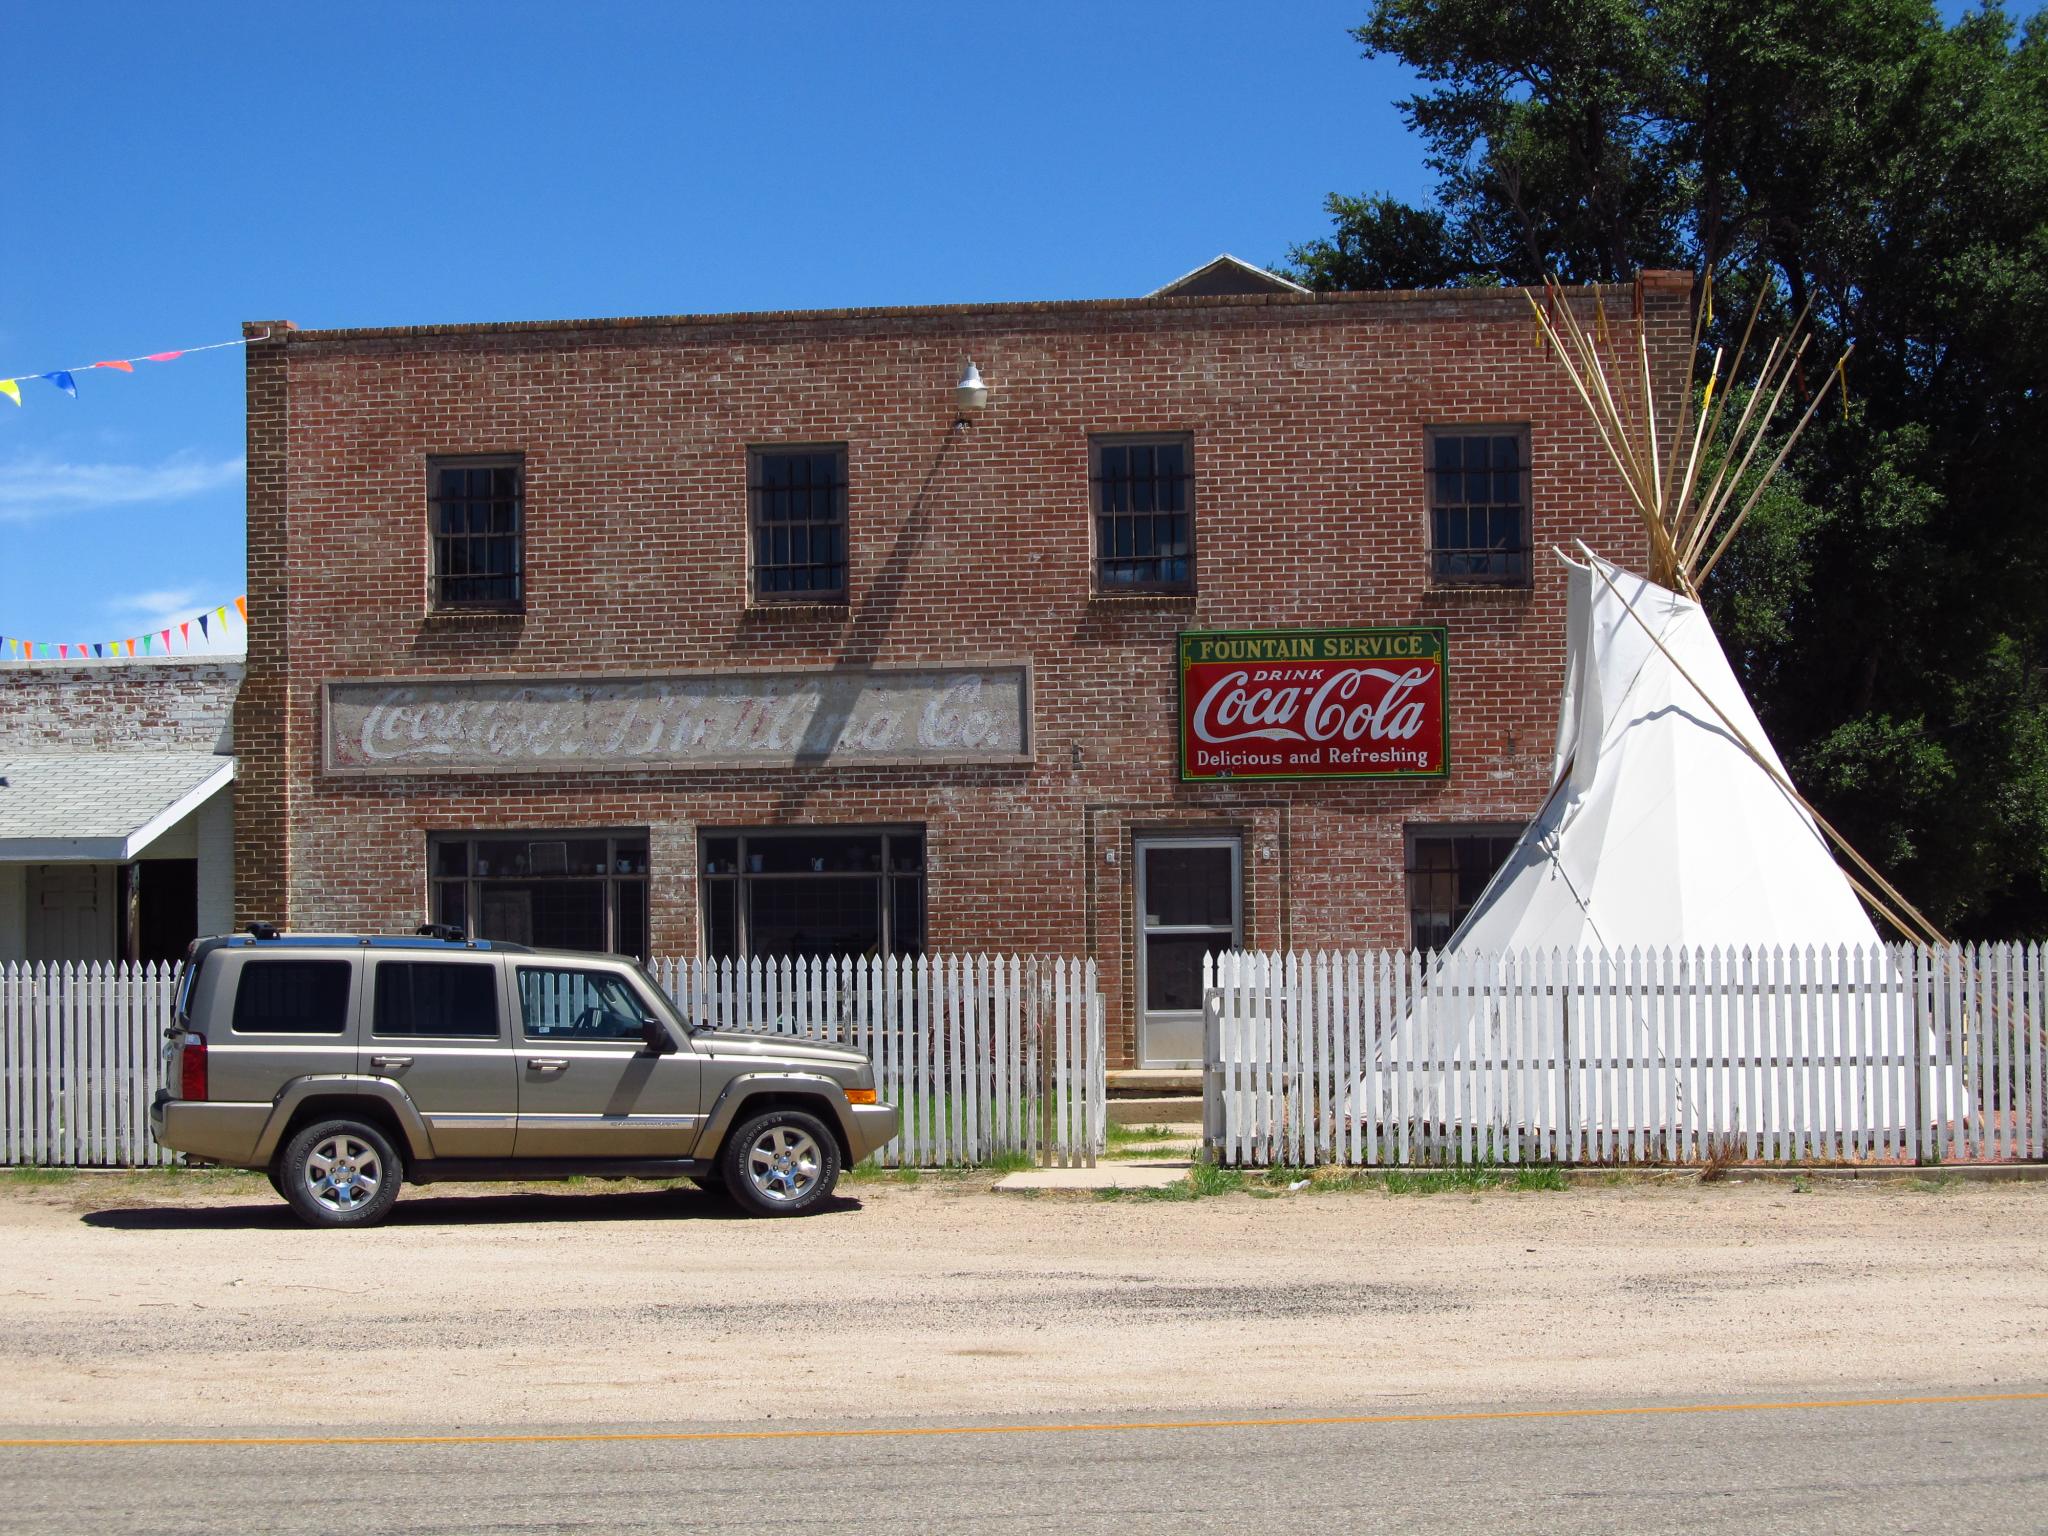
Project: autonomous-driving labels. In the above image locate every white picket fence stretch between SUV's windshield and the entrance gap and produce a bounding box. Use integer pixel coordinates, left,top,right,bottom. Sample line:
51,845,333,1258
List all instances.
649,954,1108,1167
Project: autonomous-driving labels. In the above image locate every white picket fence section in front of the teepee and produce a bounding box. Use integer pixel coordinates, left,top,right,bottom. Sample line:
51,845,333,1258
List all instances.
1204,944,2048,1165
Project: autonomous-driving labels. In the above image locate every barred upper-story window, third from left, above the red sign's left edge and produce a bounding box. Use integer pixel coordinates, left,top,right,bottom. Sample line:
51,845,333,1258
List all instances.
1087,432,1194,594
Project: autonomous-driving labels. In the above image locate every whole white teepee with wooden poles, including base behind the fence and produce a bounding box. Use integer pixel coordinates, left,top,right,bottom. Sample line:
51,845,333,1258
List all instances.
1352,285,1956,1151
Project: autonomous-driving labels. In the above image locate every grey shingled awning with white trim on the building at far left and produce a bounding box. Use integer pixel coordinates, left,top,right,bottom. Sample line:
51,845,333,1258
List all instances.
0,752,236,864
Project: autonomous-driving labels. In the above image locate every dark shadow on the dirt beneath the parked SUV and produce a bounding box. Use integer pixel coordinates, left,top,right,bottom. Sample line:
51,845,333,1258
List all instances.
80,1190,860,1233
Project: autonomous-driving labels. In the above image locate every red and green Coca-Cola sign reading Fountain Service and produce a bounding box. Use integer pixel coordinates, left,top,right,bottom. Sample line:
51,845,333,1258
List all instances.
1180,629,1450,780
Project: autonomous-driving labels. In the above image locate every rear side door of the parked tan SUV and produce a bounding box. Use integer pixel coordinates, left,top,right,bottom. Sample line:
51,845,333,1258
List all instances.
362,954,518,1157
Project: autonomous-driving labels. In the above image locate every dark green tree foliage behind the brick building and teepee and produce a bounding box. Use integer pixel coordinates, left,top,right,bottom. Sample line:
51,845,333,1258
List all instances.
1290,0,2048,936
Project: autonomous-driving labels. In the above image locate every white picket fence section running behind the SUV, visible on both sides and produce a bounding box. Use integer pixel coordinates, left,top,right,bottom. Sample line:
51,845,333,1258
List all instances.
0,954,1106,1167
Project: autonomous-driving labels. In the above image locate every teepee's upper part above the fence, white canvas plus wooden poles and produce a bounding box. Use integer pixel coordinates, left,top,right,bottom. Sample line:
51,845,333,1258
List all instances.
1446,274,1944,954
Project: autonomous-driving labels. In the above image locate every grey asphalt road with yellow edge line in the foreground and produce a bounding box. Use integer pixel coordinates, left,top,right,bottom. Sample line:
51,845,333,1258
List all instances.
0,1389,2048,1536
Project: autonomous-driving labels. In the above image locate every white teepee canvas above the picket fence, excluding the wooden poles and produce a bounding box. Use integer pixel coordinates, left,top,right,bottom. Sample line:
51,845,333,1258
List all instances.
1448,557,1878,954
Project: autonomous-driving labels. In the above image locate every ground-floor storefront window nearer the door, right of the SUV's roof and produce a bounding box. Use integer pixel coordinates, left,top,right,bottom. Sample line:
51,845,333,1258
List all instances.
700,827,924,961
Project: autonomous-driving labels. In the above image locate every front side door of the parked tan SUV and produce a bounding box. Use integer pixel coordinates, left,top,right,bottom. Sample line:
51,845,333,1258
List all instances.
508,961,702,1157
